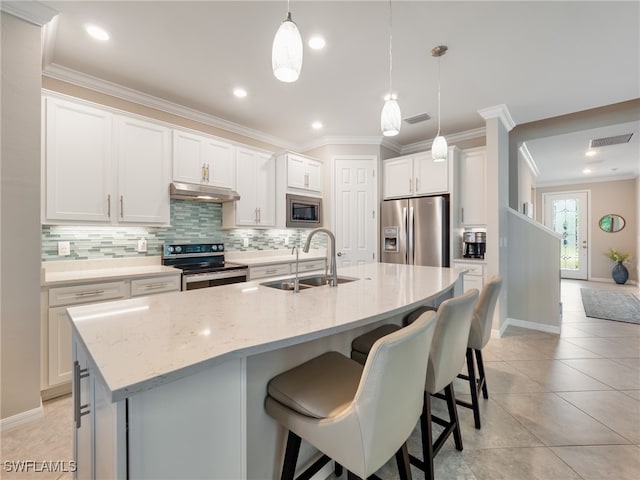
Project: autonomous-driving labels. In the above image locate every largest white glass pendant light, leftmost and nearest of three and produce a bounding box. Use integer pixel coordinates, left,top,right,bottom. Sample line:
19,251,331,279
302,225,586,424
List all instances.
271,0,302,83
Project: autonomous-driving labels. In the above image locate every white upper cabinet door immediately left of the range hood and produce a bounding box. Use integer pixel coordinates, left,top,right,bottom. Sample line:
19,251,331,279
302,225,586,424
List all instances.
117,116,171,224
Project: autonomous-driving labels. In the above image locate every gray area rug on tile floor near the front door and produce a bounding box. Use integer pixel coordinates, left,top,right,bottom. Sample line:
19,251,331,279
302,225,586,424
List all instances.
580,288,640,323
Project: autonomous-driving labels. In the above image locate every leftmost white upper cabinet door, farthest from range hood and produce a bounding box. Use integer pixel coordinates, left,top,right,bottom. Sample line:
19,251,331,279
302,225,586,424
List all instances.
44,98,115,223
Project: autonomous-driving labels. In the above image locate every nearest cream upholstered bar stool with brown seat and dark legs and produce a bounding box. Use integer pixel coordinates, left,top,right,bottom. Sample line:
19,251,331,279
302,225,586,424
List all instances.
265,313,435,479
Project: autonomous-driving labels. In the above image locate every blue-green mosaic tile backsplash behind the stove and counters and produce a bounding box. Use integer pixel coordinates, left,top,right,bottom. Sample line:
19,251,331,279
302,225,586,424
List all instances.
42,200,326,262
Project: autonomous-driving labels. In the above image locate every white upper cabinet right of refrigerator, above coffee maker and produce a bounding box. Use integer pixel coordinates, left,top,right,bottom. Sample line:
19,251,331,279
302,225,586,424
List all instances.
459,147,487,226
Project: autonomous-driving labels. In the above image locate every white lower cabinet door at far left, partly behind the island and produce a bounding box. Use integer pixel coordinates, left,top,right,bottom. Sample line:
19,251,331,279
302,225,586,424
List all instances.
48,307,73,387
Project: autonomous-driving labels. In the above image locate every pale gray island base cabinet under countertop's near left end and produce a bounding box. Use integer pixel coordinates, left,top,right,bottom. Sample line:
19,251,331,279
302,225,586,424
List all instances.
73,336,246,480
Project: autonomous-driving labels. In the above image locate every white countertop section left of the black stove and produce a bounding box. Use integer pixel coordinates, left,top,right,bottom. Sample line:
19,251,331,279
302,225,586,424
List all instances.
40,256,182,287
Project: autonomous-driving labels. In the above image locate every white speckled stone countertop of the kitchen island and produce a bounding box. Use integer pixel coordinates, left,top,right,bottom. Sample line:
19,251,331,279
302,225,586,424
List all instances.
68,263,462,402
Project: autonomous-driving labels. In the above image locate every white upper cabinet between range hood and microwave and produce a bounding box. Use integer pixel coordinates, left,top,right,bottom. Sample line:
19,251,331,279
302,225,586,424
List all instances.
222,147,276,228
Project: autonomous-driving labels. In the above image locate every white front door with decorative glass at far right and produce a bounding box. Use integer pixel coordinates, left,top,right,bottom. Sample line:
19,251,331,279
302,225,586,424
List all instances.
543,191,589,280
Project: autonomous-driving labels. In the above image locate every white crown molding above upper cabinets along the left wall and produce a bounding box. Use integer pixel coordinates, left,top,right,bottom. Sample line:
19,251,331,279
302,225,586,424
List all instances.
42,64,298,151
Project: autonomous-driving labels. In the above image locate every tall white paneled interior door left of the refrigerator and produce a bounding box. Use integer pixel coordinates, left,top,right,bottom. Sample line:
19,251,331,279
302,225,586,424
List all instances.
333,156,377,267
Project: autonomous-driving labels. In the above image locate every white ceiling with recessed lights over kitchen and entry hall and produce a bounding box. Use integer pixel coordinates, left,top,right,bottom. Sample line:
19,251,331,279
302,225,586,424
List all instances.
41,0,640,183
